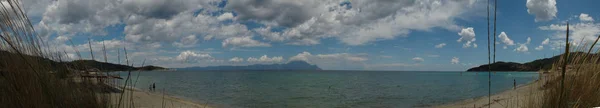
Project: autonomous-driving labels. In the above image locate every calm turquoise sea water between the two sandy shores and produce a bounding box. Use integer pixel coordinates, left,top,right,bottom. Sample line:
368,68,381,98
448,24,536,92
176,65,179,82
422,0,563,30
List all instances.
116,71,538,108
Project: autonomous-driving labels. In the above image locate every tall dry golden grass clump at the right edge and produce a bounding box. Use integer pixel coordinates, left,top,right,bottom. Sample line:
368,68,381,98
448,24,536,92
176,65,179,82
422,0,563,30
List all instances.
525,23,600,108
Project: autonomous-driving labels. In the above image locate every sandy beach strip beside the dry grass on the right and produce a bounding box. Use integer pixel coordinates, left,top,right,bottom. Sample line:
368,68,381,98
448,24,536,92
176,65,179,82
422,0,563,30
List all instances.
436,80,542,108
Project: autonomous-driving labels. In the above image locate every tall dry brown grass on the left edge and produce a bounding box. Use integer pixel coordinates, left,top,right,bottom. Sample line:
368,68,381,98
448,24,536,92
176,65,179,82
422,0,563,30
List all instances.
0,0,109,108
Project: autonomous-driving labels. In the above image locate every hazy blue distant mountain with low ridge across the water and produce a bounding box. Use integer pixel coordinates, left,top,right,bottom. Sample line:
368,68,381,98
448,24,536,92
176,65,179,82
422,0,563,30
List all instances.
177,61,321,71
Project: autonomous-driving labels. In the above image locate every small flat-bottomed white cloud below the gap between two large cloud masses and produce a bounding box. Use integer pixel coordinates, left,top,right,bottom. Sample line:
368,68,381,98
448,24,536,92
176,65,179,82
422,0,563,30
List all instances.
222,36,271,47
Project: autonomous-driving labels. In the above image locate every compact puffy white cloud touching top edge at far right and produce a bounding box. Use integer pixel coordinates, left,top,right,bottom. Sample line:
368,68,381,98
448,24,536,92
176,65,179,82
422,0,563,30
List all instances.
525,0,558,22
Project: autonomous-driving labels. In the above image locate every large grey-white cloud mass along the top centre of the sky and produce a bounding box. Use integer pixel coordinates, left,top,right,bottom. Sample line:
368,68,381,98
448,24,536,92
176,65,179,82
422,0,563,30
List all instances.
237,0,476,45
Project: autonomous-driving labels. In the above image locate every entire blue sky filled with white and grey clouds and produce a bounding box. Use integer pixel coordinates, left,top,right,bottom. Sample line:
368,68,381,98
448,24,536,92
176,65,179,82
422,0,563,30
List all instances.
17,0,600,71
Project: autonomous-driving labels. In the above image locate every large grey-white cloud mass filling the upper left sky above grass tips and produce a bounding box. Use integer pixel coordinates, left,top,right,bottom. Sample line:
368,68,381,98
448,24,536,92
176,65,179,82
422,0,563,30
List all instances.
33,0,251,47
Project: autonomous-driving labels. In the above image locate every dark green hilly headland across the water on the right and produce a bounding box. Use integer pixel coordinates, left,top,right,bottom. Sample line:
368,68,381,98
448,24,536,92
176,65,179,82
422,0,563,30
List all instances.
467,52,598,71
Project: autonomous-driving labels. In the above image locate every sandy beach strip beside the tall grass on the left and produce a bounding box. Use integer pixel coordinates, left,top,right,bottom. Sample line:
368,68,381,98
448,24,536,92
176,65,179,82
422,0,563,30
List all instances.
108,89,210,108
